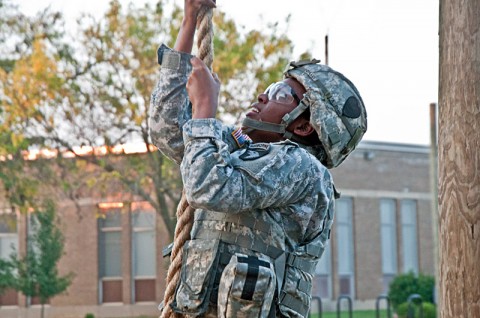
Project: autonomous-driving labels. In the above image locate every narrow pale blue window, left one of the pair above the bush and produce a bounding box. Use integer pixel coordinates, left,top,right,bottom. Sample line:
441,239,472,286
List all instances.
380,199,397,293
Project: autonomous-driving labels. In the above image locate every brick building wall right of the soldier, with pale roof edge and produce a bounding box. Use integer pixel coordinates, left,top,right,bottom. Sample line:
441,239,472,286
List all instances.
326,142,435,307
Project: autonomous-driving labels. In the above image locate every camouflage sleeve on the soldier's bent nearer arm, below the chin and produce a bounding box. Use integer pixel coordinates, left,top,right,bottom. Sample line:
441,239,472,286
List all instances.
180,119,317,212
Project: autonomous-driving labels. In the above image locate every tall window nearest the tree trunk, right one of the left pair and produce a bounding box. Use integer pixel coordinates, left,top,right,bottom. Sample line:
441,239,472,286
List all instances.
132,203,156,302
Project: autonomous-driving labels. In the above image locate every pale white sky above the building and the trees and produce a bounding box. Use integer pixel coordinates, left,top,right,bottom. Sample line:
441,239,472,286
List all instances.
15,0,439,145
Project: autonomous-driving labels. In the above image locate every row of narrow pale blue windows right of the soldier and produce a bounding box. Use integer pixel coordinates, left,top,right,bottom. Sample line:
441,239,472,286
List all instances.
314,198,418,299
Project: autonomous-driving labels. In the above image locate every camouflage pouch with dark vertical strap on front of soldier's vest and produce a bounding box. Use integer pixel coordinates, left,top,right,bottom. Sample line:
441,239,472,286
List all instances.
217,253,276,318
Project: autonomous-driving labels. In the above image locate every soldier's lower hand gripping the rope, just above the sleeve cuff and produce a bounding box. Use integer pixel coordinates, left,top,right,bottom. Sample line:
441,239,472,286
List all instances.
187,57,220,119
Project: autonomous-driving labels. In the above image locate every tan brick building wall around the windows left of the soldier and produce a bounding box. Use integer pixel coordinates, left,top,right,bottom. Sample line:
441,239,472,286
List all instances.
0,198,169,318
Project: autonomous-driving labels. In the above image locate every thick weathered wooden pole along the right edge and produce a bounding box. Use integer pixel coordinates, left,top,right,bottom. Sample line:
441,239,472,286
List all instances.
438,0,480,318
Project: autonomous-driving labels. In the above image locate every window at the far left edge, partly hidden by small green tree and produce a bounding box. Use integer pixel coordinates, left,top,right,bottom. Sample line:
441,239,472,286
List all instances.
0,210,18,307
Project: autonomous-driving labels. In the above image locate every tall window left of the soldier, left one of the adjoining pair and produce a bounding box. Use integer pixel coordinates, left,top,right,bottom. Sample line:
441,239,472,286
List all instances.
98,208,123,303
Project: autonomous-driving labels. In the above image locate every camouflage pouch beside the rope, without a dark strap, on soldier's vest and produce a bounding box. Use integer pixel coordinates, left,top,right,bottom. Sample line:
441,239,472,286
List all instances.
172,239,219,316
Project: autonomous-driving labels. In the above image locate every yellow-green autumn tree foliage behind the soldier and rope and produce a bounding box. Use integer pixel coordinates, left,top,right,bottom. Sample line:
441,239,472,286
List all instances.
0,0,306,235
